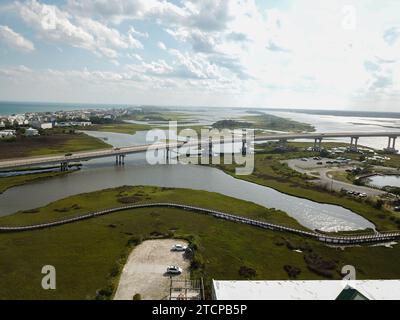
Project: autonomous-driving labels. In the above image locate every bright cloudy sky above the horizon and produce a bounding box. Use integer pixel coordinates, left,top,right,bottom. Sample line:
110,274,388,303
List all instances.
0,0,400,111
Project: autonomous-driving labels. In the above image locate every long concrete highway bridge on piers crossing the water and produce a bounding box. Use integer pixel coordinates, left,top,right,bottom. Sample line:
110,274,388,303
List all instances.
0,131,400,170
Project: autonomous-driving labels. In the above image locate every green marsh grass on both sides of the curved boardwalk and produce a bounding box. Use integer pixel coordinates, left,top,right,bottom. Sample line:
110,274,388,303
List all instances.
0,187,400,299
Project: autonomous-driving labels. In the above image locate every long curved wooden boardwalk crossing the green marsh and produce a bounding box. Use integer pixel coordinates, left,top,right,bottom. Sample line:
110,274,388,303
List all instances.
0,202,400,245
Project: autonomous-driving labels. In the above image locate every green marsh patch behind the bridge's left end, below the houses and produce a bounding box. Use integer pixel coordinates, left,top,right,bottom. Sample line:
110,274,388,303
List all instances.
0,131,110,159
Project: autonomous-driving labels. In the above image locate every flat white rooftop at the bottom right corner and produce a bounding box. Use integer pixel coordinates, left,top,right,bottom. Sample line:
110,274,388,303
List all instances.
213,280,400,300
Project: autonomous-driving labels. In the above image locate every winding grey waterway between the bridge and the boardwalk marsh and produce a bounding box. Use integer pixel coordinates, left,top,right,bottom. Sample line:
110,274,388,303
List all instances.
0,132,374,231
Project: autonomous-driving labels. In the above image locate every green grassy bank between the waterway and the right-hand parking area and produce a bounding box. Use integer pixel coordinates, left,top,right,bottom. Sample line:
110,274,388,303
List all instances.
217,143,400,231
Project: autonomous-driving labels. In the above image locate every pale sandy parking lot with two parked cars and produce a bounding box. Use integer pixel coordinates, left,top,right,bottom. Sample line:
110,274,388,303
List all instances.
114,239,190,300
